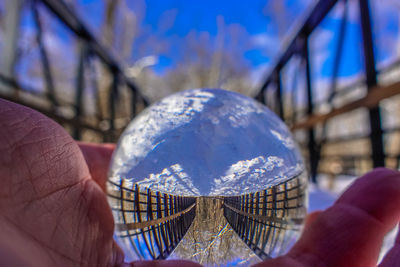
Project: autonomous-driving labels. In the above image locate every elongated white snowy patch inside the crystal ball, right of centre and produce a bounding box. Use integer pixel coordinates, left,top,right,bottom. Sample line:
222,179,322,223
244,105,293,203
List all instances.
210,156,303,196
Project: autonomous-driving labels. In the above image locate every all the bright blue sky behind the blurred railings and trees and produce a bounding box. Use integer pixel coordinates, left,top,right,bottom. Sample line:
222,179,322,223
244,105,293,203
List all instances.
11,0,400,91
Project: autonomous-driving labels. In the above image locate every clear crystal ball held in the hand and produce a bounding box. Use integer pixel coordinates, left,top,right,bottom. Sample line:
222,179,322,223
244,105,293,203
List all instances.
107,89,307,266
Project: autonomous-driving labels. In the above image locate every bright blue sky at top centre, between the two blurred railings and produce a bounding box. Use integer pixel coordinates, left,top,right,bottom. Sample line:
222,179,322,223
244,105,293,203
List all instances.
134,0,311,73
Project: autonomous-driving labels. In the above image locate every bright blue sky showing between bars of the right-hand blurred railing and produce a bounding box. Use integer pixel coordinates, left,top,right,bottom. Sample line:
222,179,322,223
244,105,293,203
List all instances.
313,0,400,77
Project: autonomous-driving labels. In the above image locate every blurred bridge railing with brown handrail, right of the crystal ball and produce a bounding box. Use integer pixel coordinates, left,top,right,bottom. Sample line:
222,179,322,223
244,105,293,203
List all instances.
256,0,400,182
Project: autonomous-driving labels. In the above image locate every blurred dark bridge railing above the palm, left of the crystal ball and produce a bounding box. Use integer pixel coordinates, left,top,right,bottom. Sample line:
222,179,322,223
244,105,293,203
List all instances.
0,0,148,142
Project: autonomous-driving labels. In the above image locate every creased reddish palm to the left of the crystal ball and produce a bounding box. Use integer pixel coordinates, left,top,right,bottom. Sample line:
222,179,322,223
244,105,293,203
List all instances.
0,99,199,267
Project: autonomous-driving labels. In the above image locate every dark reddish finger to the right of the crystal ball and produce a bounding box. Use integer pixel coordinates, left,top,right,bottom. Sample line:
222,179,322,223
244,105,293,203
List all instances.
288,168,400,266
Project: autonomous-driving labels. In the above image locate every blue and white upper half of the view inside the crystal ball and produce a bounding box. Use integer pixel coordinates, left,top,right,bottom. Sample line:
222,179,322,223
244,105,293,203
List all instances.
111,89,302,195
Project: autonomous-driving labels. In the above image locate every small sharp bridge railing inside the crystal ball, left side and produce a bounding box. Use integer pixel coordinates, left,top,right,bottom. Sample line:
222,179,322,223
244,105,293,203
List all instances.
107,180,196,259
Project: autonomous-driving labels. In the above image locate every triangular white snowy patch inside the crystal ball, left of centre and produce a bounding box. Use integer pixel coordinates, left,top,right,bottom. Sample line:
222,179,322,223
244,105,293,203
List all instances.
133,164,200,196
